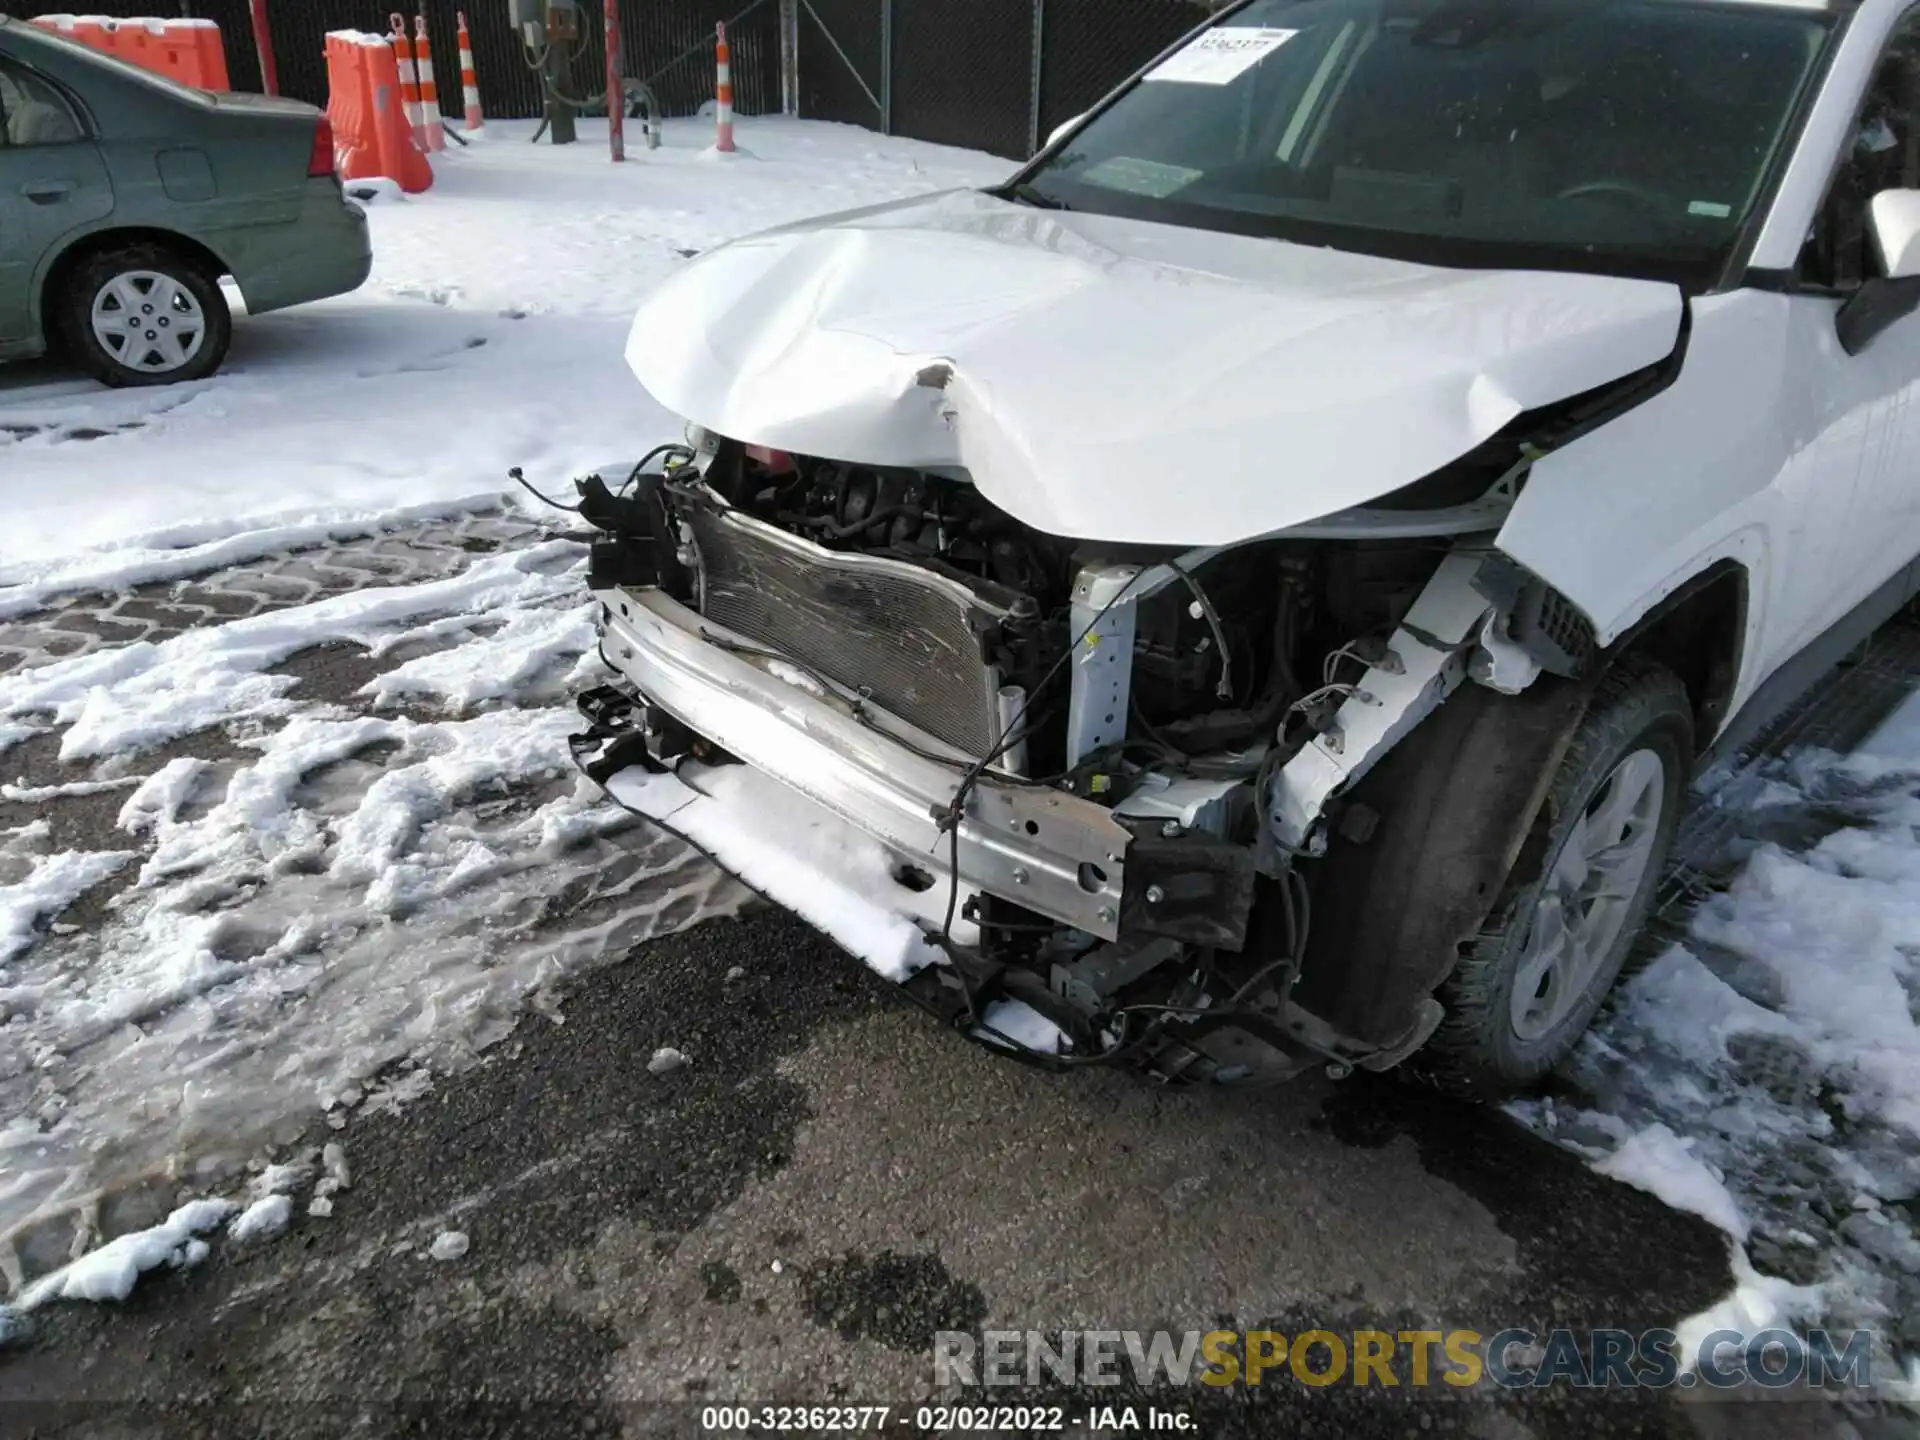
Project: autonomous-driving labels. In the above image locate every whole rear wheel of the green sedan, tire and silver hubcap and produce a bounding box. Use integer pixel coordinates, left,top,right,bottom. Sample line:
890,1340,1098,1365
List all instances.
56,246,232,386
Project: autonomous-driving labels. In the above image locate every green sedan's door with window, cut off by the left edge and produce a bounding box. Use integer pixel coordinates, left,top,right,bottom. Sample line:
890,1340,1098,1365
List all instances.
0,56,113,346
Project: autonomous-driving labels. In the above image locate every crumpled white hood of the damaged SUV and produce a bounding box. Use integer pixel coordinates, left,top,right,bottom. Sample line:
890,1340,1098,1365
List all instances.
626,192,1684,545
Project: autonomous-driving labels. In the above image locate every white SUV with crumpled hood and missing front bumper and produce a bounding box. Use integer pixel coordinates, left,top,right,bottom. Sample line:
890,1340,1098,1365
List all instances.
576,0,1920,1094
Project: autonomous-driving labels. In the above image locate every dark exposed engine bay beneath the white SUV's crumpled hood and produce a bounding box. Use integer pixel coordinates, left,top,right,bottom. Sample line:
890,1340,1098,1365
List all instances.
705,444,1450,794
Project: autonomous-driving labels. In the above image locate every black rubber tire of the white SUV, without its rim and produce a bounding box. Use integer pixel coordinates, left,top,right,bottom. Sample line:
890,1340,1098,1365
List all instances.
1407,660,1693,1100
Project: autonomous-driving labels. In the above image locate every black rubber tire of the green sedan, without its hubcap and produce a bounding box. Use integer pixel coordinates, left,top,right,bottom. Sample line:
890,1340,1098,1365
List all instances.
54,244,234,386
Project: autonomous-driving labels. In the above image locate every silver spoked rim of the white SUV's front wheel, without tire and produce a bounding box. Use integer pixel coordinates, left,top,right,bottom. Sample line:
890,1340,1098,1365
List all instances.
1513,751,1667,1041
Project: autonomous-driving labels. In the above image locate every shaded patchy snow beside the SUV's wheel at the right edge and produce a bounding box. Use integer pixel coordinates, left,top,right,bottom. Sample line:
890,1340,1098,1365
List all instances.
1509,733,1920,1375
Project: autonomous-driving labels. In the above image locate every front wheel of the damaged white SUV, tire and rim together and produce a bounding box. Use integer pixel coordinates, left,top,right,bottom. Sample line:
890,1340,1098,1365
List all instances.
1409,660,1693,1096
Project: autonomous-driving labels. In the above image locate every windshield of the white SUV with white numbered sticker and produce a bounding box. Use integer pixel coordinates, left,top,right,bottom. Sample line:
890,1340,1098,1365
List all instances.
1016,0,1828,280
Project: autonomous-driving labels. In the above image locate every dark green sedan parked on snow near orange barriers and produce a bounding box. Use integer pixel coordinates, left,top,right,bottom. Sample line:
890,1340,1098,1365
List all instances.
0,15,372,386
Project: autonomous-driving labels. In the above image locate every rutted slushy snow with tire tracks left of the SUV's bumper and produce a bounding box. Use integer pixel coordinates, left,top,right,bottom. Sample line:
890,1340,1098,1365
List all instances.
0,511,745,1288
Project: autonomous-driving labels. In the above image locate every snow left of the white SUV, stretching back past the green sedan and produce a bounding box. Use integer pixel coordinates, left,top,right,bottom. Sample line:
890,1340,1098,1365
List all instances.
0,119,1006,1294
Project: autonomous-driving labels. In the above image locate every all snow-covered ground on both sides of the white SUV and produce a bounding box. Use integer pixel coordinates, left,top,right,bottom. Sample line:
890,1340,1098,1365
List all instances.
0,112,1920,1413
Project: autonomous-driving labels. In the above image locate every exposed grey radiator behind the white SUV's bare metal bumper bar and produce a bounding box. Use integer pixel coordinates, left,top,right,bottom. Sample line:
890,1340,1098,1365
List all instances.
682,507,1006,758
